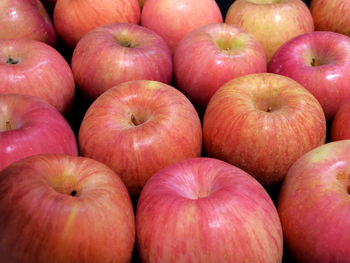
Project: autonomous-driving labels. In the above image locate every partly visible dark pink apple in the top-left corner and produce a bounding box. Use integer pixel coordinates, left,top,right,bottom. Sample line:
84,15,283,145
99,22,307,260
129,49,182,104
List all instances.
0,0,57,46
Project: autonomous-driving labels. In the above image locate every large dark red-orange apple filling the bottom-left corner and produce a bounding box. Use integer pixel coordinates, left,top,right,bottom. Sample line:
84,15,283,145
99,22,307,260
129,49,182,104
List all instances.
0,154,135,263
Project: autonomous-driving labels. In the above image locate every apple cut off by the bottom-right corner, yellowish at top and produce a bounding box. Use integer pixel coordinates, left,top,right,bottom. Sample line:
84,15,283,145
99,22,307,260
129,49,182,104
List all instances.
278,140,350,263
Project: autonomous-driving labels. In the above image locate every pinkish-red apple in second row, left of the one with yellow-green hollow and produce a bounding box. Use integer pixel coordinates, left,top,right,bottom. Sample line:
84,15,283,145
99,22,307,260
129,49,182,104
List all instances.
71,23,173,99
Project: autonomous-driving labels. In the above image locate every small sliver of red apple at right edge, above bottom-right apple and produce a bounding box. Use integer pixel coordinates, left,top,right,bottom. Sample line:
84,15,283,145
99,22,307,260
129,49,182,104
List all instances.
329,99,350,141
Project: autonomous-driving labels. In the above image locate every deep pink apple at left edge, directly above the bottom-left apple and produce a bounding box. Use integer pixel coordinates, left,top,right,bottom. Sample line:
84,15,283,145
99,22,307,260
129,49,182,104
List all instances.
0,94,78,170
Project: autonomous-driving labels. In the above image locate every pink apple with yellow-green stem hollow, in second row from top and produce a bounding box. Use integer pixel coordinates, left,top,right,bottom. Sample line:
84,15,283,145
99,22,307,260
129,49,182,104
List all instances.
174,23,266,111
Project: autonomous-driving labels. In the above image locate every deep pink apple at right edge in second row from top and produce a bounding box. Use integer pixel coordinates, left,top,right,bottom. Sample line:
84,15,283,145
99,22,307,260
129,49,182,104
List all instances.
268,31,350,121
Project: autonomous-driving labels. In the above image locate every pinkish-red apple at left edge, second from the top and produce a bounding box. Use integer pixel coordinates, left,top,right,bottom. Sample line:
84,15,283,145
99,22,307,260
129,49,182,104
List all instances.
0,39,75,113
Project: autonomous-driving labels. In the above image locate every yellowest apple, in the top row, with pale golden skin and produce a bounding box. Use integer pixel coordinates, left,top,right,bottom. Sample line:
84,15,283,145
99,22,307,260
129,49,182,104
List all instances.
225,0,314,61
